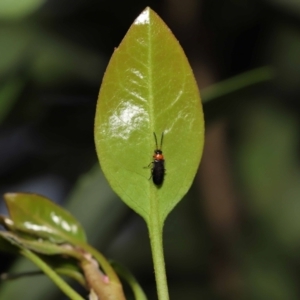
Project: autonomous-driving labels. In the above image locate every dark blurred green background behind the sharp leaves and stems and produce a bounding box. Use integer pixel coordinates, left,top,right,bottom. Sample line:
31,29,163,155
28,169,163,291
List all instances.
0,0,300,300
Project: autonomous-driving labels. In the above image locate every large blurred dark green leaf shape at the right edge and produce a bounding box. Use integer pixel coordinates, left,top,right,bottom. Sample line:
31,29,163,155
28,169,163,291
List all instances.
236,101,300,250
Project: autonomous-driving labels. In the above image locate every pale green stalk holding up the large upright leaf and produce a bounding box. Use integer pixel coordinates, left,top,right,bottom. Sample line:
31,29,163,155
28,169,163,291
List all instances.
148,199,169,300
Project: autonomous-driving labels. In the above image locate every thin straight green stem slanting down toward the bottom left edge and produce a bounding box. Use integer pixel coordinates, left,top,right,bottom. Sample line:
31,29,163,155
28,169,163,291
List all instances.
20,249,84,300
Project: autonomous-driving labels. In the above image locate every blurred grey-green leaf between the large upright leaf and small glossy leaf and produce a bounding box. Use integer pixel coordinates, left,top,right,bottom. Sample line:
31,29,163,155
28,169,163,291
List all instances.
66,164,128,246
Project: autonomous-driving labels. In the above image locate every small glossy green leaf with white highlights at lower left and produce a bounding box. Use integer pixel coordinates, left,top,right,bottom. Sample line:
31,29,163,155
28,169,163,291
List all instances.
4,193,86,243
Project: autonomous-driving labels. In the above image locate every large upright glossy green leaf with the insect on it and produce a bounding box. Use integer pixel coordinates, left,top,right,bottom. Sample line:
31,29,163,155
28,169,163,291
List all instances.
95,8,204,226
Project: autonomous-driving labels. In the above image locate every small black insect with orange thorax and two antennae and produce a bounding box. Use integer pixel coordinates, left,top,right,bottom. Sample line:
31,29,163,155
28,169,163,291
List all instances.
150,132,166,186
